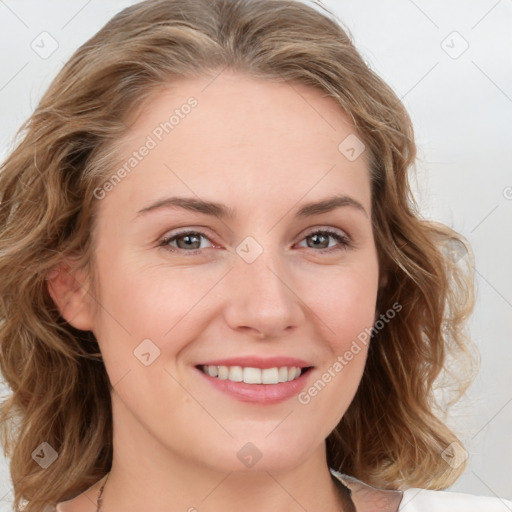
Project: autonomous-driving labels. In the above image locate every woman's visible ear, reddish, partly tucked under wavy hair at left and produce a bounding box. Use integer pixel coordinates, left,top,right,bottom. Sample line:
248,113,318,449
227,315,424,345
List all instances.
46,258,94,331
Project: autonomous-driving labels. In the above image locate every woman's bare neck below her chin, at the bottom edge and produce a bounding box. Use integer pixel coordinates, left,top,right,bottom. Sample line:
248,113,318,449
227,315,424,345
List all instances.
98,446,355,512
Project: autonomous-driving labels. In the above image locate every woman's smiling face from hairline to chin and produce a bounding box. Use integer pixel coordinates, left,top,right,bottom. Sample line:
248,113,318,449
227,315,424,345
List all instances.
62,72,379,471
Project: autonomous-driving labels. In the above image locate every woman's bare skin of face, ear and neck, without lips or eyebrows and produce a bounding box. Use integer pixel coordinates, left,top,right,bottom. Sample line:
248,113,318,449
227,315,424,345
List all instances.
49,71,379,512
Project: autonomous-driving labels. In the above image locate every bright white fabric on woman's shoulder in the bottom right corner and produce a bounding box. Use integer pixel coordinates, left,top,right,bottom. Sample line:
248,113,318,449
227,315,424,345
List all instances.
398,488,512,512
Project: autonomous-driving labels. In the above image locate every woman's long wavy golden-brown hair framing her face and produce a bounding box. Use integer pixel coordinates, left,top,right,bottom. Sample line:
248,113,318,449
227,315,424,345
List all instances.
0,0,479,512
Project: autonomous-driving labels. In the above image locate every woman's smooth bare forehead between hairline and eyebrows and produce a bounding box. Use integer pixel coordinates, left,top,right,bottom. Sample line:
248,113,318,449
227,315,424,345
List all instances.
96,72,371,222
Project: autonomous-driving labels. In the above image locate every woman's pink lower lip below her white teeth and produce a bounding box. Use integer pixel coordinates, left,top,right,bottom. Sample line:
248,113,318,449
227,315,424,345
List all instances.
194,368,313,404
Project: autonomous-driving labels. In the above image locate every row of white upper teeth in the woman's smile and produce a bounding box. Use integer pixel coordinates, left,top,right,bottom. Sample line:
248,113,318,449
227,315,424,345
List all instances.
201,365,301,384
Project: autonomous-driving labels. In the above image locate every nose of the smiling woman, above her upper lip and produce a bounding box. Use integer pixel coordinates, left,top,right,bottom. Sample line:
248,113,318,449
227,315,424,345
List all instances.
225,247,305,339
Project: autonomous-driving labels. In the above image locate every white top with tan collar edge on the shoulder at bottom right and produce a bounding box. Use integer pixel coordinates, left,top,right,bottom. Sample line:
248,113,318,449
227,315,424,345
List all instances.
330,468,512,512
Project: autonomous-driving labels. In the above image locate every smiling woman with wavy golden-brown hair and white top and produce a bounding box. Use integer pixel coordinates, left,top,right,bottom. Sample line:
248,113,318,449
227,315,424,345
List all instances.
0,0,510,512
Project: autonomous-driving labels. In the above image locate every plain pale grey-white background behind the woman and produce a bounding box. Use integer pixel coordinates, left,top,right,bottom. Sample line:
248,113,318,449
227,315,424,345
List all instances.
0,0,512,511
